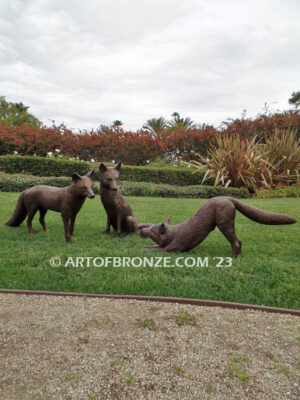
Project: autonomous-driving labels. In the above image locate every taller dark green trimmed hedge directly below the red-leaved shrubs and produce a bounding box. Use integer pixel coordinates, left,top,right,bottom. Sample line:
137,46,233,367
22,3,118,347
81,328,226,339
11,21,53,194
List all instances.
0,156,213,186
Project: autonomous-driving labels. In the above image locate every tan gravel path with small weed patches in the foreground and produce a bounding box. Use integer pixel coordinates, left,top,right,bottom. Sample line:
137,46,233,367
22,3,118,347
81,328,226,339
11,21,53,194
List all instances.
0,294,300,400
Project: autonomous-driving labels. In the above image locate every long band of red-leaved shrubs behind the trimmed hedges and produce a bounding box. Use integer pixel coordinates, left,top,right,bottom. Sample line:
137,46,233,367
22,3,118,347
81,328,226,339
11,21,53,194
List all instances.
0,111,300,165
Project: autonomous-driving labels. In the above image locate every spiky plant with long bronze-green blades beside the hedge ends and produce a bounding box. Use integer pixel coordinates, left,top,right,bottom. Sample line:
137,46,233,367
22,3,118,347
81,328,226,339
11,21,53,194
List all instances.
186,130,300,191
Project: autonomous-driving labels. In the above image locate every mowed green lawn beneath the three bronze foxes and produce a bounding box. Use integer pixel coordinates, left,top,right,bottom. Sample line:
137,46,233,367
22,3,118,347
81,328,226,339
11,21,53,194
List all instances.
0,193,300,308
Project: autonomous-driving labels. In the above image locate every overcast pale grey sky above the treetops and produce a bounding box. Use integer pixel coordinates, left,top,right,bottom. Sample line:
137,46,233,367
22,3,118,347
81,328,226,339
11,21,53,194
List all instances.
0,0,300,129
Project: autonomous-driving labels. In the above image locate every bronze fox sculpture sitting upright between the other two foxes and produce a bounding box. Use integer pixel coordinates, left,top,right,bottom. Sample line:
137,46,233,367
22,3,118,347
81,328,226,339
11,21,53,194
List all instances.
99,163,138,236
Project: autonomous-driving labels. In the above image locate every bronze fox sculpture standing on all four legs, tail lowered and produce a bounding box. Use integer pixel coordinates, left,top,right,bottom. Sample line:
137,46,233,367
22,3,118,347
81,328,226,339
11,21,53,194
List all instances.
5,170,95,242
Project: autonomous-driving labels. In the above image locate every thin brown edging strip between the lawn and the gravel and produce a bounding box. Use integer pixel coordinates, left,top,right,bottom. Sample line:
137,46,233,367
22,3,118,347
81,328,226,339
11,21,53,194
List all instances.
0,289,300,317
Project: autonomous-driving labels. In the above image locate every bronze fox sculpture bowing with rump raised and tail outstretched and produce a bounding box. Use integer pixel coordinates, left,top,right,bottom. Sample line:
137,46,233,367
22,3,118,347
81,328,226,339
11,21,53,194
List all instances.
138,197,297,257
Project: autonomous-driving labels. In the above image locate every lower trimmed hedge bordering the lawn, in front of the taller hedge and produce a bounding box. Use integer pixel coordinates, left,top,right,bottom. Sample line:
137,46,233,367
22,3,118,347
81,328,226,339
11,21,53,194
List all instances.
0,174,249,199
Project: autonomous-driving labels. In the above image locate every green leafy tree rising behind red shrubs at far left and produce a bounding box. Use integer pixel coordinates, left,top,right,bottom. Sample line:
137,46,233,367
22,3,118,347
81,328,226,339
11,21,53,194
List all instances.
0,96,42,126
